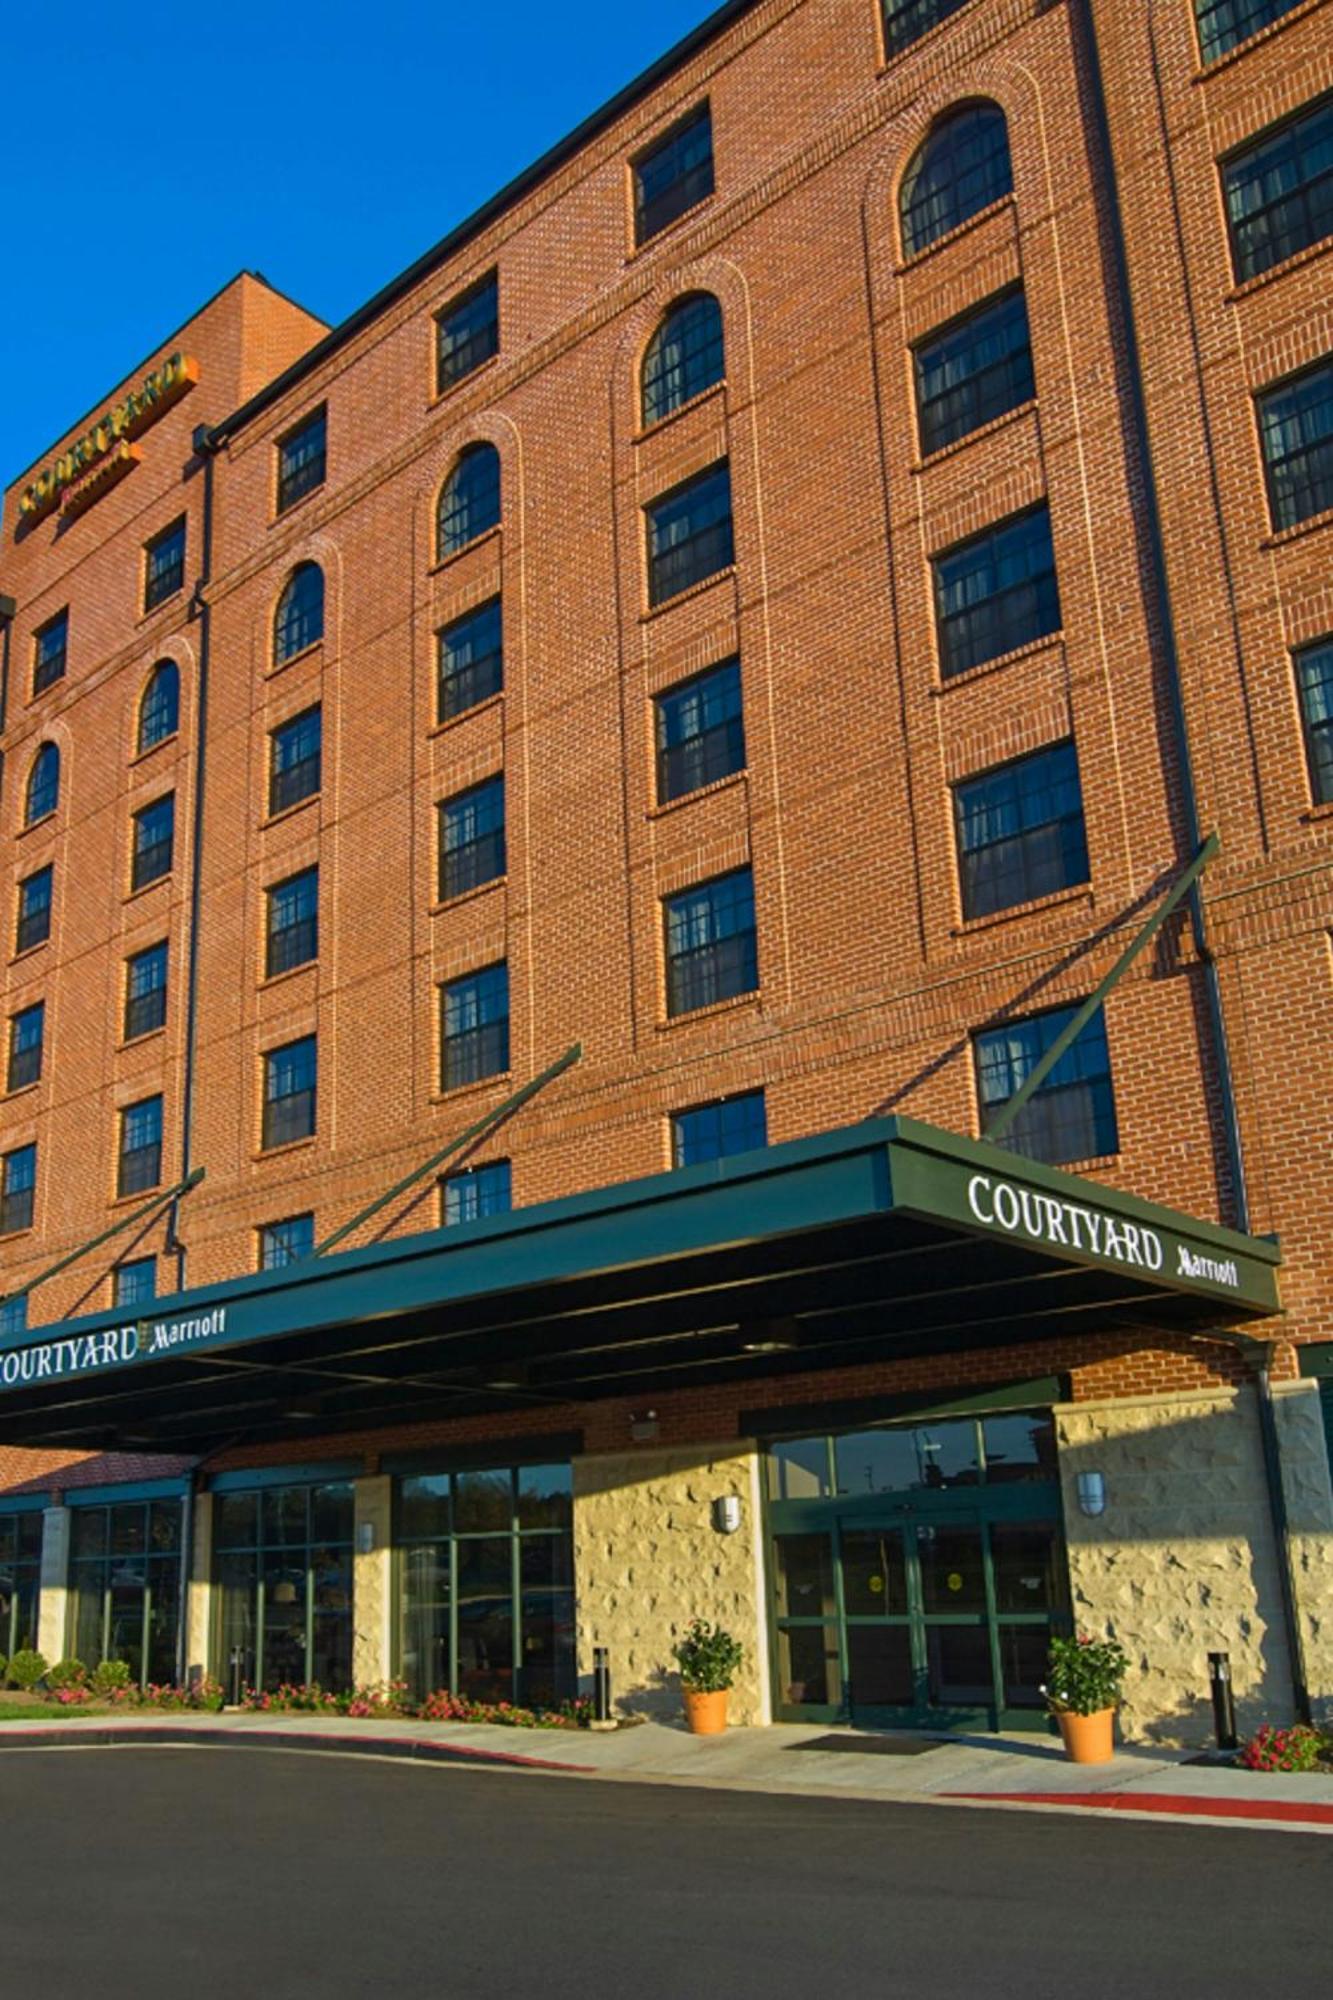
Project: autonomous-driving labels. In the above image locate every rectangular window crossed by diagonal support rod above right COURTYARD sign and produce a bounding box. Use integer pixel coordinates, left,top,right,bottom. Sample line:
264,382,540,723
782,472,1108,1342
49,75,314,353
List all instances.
973,1006,1121,1166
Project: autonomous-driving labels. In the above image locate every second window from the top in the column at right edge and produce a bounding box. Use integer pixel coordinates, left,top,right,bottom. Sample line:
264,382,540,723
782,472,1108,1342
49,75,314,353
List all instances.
1223,98,1333,284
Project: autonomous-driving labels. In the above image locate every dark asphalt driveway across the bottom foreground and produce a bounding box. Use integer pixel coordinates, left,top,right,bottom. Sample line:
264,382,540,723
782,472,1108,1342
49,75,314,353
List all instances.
0,1750,1333,2000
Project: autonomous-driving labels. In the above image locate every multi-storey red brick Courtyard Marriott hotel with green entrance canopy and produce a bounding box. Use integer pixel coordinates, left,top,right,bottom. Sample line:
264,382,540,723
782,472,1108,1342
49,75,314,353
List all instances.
0,0,1333,1736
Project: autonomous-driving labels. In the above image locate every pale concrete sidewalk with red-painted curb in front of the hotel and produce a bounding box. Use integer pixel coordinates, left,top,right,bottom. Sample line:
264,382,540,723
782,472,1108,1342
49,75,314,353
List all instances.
0,1712,1333,1832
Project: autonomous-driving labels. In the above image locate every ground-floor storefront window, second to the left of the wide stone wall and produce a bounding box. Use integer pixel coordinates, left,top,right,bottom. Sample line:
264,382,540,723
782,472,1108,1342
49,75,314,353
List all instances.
212,1480,354,1690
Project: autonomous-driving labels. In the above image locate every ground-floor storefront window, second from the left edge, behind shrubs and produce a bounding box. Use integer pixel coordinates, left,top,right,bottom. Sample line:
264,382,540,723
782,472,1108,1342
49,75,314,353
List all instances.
66,1500,180,1686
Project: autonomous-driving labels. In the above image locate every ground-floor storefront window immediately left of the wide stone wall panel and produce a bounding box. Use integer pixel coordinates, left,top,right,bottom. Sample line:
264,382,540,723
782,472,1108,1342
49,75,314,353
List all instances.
394,1466,574,1704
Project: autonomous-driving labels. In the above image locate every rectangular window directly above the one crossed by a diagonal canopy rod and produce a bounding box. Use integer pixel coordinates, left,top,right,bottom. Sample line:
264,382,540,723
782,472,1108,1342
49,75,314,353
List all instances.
953,744,1087,918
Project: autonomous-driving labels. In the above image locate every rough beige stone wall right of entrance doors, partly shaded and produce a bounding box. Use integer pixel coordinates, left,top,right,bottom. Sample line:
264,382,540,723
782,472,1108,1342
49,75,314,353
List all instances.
1055,1388,1333,1744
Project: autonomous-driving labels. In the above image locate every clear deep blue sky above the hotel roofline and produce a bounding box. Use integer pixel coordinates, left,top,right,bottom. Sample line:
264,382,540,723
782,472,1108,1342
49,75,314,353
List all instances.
0,0,717,486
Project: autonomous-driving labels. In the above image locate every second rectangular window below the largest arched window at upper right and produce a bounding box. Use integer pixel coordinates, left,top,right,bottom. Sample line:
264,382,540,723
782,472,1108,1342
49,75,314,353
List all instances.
933,502,1061,680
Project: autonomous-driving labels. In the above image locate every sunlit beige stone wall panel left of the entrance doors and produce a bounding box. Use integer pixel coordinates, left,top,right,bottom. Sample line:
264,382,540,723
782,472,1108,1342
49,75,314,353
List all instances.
574,1446,769,1722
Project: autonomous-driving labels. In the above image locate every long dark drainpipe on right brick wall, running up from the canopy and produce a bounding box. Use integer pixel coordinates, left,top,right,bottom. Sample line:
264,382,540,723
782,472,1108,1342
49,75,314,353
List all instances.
1069,0,1249,1234
